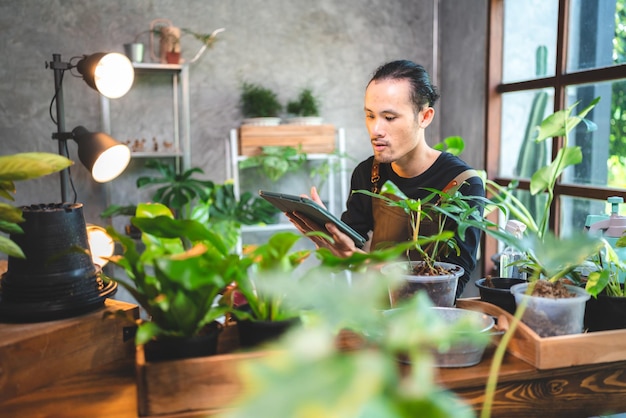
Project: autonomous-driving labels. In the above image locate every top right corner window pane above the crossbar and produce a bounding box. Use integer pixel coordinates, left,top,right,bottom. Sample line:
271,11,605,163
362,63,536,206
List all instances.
567,0,626,72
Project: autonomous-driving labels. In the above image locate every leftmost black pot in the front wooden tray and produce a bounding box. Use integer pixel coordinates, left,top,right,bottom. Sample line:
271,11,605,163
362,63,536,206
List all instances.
144,322,222,361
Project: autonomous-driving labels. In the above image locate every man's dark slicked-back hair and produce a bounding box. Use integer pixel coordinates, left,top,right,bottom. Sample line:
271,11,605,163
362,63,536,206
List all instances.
367,60,439,114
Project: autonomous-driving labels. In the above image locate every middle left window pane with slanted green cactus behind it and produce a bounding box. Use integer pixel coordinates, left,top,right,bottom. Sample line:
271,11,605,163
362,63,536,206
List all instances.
499,89,554,179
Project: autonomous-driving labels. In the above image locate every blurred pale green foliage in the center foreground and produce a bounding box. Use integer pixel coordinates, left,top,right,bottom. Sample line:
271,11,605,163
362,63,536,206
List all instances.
225,268,484,418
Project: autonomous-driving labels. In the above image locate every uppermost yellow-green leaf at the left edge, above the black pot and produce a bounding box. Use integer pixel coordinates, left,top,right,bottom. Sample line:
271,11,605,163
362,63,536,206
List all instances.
0,152,74,181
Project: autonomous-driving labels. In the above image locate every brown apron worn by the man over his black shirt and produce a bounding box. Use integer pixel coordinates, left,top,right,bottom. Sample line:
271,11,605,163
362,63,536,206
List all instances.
370,160,478,253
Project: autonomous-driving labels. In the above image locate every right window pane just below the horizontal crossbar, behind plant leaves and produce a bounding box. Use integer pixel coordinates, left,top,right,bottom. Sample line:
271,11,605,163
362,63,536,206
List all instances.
562,80,626,188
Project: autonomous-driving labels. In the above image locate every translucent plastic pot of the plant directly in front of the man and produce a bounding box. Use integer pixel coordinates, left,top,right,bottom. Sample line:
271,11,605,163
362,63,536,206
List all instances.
381,261,464,307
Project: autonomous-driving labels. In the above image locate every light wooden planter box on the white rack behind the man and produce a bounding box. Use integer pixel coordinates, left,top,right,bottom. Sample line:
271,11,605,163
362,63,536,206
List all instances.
239,125,335,156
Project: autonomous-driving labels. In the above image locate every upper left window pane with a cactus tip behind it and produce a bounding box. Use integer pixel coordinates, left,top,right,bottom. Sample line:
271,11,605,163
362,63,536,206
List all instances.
502,0,559,83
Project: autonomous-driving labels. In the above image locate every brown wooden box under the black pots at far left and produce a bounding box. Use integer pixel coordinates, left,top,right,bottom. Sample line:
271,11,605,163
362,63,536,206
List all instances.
0,299,139,401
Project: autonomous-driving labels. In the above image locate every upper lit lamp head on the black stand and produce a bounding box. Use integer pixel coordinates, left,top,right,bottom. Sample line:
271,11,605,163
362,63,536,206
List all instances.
76,52,135,99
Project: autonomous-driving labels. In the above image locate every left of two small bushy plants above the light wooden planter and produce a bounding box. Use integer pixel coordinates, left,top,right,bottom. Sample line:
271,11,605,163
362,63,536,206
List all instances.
240,82,283,126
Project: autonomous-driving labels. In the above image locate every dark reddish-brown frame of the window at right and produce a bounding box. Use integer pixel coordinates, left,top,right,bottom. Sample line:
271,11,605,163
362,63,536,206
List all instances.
483,0,626,274
